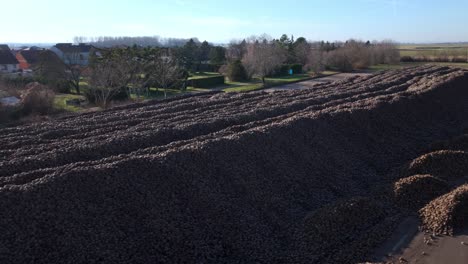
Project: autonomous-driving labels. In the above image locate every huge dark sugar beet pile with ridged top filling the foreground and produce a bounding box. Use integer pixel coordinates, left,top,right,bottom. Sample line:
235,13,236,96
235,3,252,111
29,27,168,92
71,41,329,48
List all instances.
0,66,468,263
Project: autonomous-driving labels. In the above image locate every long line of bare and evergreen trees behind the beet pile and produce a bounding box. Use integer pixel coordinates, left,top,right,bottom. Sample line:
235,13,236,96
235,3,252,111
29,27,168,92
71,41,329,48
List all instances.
3,34,400,119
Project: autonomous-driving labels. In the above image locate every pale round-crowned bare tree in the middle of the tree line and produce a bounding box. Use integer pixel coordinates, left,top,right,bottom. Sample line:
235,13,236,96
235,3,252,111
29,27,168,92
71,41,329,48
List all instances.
242,39,287,86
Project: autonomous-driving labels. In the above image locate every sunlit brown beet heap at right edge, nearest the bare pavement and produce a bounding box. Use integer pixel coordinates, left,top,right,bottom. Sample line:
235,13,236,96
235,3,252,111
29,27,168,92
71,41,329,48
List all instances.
420,184,468,235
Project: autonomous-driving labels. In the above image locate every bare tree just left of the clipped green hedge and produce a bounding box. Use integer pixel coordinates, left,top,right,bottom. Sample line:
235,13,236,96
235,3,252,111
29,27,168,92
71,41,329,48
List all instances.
145,49,182,98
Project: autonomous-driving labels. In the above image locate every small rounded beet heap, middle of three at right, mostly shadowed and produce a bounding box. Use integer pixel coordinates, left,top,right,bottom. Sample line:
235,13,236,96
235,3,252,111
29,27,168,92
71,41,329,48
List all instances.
393,175,450,209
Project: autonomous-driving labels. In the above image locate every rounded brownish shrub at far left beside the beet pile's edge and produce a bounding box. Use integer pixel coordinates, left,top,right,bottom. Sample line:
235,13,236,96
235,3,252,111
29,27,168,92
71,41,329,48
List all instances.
21,82,55,115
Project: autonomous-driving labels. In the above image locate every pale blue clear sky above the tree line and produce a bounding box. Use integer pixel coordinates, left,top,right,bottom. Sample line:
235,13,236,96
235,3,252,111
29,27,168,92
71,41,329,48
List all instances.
0,0,468,43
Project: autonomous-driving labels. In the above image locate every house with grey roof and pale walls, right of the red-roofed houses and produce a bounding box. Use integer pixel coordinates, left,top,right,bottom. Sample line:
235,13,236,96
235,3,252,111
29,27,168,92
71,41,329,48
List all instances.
50,43,94,66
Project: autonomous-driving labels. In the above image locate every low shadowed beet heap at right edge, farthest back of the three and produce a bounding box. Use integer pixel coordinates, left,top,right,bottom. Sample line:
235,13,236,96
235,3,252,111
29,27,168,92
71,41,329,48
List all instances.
407,150,468,180
